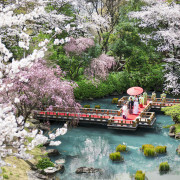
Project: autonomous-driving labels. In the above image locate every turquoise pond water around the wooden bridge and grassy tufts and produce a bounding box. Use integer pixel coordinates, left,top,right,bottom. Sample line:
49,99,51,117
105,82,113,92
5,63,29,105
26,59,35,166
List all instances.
47,97,180,180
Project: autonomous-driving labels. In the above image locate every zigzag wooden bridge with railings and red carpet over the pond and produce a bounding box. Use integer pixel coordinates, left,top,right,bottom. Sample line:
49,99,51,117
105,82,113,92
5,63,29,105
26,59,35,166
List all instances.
34,96,180,130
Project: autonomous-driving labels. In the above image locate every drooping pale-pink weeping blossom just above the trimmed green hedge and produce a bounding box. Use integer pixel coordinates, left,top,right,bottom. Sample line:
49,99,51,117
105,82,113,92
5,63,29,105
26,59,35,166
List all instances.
85,54,115,80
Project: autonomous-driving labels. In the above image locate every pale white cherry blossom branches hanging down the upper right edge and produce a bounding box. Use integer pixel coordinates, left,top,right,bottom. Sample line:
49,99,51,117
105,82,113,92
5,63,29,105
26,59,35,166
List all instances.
129,0,180,94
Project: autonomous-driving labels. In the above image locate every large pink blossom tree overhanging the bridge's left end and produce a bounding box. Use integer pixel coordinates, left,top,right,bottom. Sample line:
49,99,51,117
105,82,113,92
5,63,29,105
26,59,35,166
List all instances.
0,60,79,122
